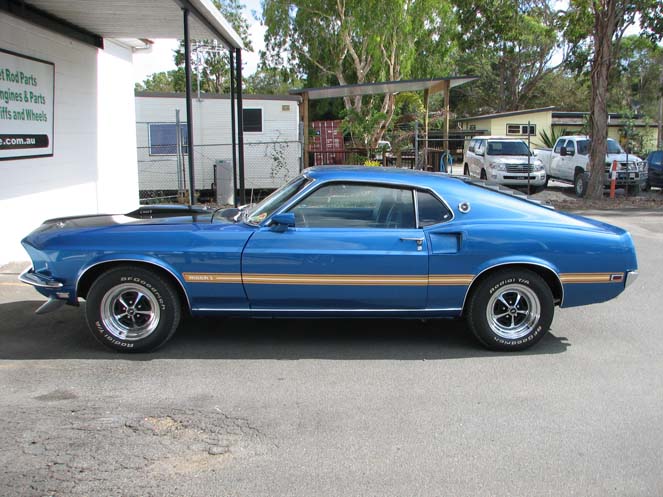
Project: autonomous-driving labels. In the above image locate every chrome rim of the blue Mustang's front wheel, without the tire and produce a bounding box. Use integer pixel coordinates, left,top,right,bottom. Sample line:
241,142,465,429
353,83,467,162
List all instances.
101,283,161,341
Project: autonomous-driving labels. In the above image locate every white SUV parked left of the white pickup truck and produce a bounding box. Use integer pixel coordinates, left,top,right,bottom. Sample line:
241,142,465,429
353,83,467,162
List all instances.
463,136,546,193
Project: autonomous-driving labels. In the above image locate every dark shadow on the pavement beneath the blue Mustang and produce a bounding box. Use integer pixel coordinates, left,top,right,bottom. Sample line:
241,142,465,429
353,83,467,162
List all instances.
0,301,570,361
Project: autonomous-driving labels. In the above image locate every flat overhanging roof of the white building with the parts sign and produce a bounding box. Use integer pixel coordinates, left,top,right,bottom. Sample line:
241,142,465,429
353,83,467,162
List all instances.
5,0,243,49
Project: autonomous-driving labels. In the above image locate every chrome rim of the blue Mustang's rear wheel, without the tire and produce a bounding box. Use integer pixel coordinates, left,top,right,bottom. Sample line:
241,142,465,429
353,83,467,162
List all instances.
486,284,541,340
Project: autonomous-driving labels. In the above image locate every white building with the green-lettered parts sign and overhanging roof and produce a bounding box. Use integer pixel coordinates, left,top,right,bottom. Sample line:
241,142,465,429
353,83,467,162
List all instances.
0,0,242,264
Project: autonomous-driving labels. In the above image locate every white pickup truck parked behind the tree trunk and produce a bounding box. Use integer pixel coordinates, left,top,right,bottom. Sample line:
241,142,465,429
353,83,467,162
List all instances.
534,136,647,197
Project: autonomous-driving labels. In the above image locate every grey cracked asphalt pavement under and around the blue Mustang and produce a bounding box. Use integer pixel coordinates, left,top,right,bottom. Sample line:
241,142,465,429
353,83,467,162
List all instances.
0,211,663,497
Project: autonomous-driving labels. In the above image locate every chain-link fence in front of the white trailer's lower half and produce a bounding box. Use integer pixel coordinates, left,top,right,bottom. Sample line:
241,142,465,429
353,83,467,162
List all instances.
138,141,302,205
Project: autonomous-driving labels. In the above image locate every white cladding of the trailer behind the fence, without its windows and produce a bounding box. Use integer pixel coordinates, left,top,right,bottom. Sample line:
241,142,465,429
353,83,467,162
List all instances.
136,95,301,189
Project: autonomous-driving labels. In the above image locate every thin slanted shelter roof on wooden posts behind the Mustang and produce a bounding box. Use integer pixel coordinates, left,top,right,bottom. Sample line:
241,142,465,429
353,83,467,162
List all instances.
289,76,479,100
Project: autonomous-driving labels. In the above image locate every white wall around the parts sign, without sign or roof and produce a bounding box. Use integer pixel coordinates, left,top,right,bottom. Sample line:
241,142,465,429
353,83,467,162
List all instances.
0,12,138,264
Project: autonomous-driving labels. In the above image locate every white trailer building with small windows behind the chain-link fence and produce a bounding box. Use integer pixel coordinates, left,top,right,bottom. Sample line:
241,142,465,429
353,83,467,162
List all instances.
136,92,301,202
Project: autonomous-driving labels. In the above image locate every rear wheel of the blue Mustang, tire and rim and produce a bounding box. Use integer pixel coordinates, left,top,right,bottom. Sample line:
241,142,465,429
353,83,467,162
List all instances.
467,269,554,351
